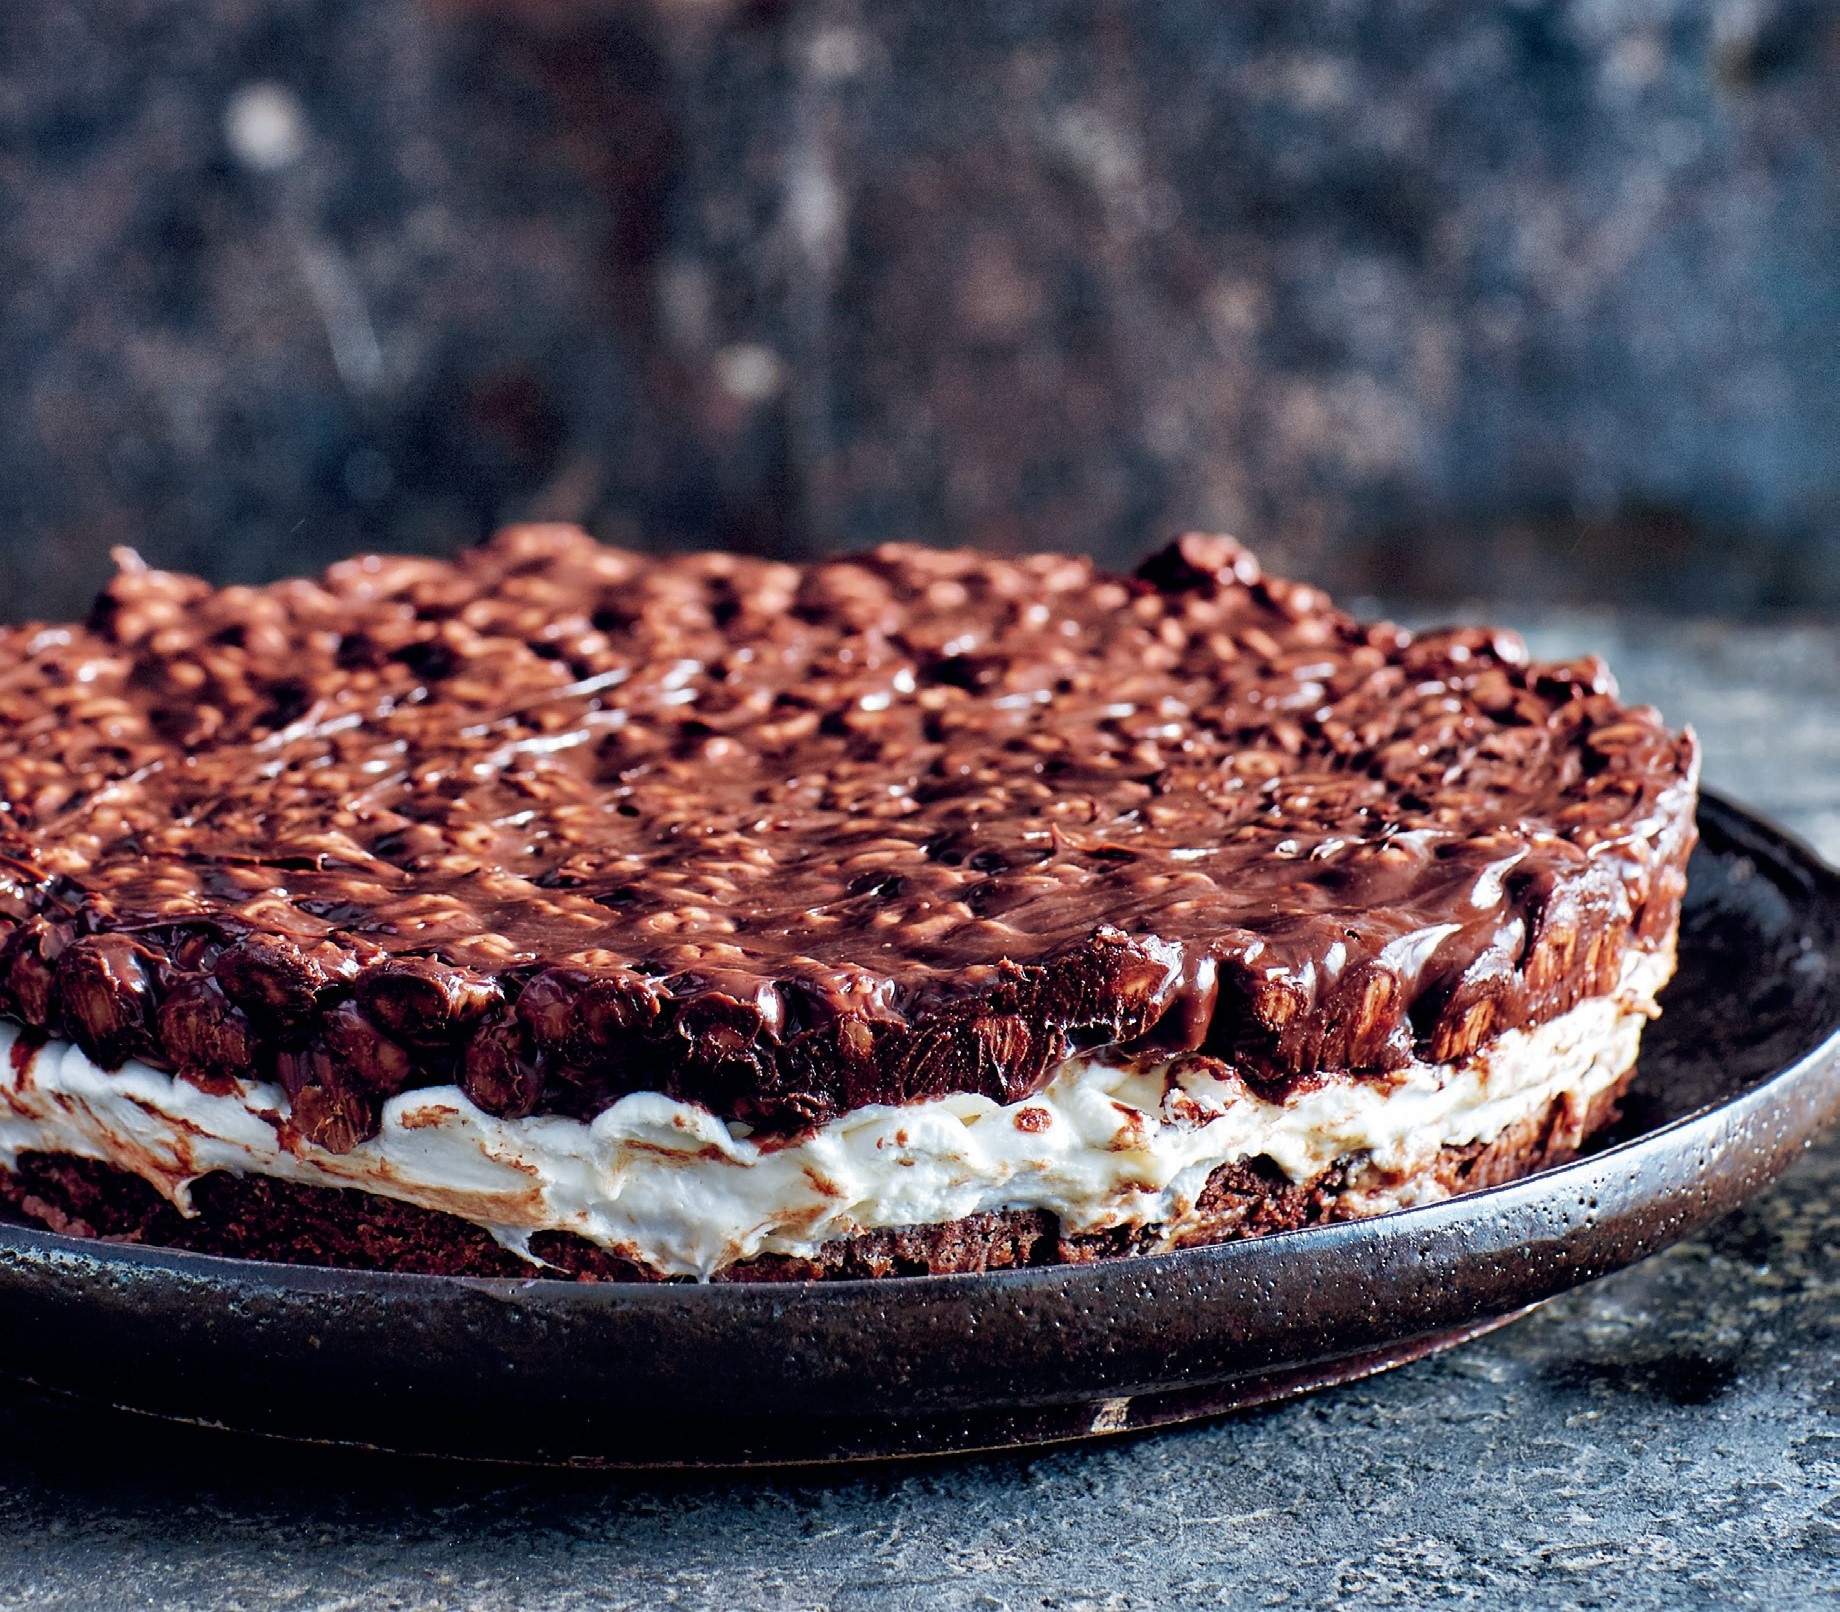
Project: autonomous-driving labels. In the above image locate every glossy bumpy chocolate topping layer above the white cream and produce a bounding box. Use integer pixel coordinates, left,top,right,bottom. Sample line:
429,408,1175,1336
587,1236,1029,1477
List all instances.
0,526,1696,1148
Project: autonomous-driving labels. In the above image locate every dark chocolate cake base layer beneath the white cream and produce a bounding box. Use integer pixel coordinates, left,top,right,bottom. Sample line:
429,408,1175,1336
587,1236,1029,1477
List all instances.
0,1075,1632,1283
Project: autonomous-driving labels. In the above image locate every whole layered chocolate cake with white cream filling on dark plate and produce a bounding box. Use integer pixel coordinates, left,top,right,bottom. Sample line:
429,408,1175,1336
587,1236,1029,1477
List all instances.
0,526,1696,1279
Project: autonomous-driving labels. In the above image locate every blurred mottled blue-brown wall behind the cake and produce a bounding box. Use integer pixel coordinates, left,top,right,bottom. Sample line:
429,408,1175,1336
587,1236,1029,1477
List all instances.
0,0,1840,615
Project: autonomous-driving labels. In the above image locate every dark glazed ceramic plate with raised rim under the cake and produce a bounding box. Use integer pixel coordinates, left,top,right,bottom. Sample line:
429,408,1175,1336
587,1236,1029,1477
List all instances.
0,799,1840,1467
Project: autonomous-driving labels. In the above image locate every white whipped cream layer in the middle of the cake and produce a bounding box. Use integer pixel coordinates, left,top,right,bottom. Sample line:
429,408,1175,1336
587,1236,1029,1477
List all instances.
0,951,1673,1277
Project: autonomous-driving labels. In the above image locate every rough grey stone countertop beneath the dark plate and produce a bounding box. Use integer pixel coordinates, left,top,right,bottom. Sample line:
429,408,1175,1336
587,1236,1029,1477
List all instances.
0,615,1840,1612
